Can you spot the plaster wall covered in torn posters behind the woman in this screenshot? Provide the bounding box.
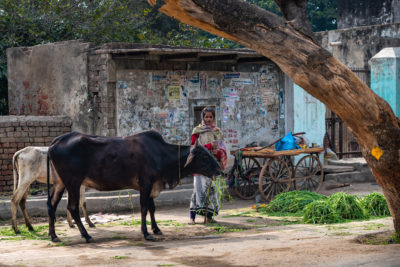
[116,64,284,155]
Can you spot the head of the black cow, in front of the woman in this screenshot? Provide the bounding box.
[185,145,222,177]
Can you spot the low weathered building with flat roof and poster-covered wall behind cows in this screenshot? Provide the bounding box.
[7,41,287,155]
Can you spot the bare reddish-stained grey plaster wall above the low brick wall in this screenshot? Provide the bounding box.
[7,41,90,132]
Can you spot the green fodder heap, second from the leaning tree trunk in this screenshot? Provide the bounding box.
[328,192,369,219]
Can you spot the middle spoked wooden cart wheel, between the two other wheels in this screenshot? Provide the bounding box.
[258,158,292,201]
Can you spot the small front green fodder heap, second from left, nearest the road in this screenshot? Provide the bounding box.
[303,200,342,223]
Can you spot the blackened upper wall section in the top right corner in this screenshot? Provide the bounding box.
[338,0,400,29]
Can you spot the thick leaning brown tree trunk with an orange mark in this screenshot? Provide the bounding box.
[148,0,400,234]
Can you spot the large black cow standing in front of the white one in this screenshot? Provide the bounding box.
[47,131,221,242]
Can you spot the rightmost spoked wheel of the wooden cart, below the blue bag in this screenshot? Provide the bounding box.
[294,155,324,191]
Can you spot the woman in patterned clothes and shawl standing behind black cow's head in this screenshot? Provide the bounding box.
[190,107,227,224]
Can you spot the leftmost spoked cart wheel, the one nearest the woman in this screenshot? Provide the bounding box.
[235,157,261,199]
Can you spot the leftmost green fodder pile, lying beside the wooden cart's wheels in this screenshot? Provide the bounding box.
[265,190,327,216]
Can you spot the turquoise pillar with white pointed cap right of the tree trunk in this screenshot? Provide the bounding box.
[370,47,400,117]
